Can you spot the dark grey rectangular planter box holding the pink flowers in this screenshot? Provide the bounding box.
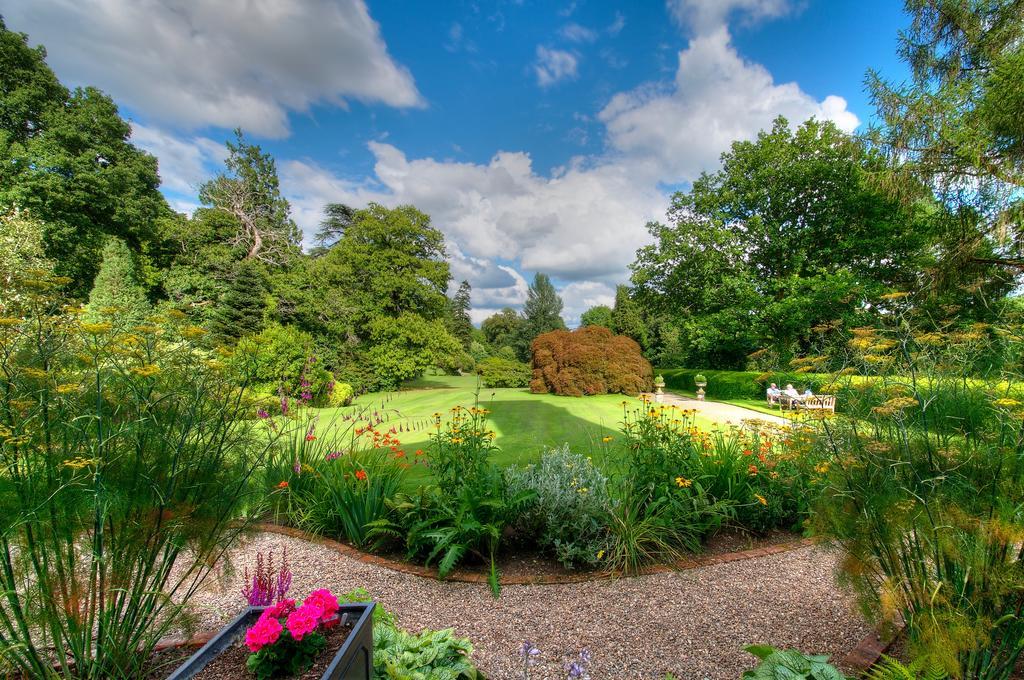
[167,602,374,680]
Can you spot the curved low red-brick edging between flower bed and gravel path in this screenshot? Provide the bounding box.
[253,523,814,586]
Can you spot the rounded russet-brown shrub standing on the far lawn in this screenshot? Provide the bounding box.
[529,326,653,396]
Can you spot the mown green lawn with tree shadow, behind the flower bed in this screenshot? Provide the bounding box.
[321,376,714,477]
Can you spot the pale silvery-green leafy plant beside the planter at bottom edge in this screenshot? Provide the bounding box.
[374,623,483,680]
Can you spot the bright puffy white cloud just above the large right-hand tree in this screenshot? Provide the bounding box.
[598,28,859,183]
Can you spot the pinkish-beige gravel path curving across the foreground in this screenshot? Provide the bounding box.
[184,534,868,680]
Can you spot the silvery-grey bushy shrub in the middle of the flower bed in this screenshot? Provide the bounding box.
[505,444,610,568]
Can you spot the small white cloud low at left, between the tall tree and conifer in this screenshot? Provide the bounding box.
[131,123,227,193]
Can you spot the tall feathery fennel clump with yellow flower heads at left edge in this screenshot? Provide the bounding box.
[0,273,272,678]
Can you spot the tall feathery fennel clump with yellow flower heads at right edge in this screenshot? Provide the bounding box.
[813,309,1024,680]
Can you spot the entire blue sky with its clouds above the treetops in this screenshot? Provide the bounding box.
[0,0,906,324]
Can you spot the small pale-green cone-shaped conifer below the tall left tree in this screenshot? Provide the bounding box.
[86,237,151,326]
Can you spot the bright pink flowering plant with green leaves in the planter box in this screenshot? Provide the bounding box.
[246,590,339,680]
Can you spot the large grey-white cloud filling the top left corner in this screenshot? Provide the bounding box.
[0,0,423,137]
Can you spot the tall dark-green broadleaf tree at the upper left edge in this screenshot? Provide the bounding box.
[0,19,170,299]
